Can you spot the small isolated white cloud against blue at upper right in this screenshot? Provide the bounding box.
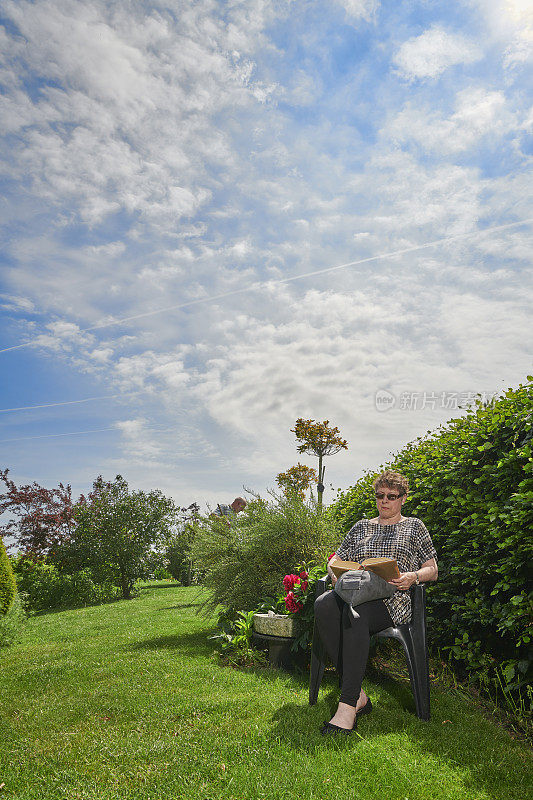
[393,25,482,79]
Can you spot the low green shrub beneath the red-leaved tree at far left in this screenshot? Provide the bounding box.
[13,556,117,611]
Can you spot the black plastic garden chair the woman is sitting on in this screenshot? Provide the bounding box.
[309,575,430,720]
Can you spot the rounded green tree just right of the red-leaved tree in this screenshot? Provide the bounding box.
[65,475,176,598]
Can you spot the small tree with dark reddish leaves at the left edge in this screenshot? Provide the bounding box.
[0,469,74,559]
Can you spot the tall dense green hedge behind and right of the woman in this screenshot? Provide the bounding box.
[329,376,533,708]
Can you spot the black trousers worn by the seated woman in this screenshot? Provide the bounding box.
[315,591,394,706]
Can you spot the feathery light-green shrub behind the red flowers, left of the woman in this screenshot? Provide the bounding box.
[193,493,339,611]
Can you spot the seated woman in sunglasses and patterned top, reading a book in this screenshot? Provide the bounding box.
[315,471,438,735]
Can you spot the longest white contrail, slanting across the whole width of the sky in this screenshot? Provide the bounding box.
[0,218,533,353]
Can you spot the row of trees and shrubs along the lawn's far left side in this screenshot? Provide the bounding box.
[0,469,199,610]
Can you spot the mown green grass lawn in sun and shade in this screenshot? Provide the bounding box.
[0,584,533,800]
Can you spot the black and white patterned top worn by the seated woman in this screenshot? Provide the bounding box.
[336,517,437,625]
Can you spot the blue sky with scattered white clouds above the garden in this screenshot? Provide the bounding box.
[0,0,533,507]
